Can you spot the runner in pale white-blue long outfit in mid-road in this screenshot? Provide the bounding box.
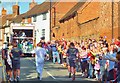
[34,43,47,80]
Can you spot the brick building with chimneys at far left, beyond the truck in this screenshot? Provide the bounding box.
[0,4,19,46]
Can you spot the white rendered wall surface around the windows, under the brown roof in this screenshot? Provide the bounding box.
[32,12,50,44]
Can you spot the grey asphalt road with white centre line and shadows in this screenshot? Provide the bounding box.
[20,57,97,83]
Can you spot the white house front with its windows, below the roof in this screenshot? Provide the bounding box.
[32,11,50,43]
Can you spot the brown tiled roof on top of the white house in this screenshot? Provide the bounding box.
[24,2,55,18]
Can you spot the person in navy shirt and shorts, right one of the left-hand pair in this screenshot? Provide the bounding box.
[10,40,23,81]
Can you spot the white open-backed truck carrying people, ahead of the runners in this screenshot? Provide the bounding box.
[10,23,36,56]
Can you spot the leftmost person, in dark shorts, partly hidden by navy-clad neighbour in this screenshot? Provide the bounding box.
[2,45,12,81]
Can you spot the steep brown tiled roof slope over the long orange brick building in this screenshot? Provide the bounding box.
[59,2,85,22]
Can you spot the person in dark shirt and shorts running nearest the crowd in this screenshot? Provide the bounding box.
[67,42,79,80]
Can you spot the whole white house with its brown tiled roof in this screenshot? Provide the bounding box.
[24,2,54,44]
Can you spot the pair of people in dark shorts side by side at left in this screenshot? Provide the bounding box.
[2,40,24,82]
